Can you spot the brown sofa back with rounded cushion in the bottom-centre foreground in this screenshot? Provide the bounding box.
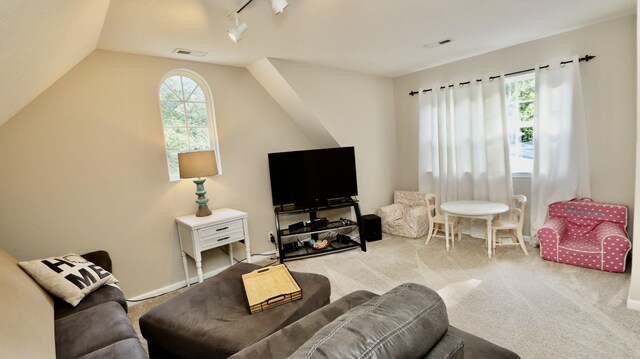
[230,283,520,359]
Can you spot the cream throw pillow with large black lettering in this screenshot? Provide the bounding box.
[18,253,118,307]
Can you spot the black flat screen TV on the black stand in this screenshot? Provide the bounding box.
[269,147,358,206]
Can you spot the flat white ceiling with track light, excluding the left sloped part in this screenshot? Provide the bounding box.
[98,0,636,77]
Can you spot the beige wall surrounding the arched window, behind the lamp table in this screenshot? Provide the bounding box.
[0,51,311,297]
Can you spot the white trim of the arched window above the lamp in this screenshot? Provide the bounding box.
[157,68,222,182]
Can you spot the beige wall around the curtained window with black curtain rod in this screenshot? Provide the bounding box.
[395,15,636,233]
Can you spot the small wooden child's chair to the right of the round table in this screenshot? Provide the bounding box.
[491,195,529,255]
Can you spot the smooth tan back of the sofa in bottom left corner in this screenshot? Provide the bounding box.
[0,249,55,358]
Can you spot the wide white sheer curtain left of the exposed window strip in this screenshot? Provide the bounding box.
[418,76,513,203]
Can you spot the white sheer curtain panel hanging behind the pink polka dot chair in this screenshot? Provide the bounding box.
[530,56,591,235]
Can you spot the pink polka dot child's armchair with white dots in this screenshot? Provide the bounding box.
[538,198,631,272]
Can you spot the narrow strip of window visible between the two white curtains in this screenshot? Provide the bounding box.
[505,73,536,175]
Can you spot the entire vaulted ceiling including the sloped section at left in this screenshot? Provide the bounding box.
[0,0,636,125]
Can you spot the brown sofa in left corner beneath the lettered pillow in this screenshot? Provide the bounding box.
[0,249,148,359]
